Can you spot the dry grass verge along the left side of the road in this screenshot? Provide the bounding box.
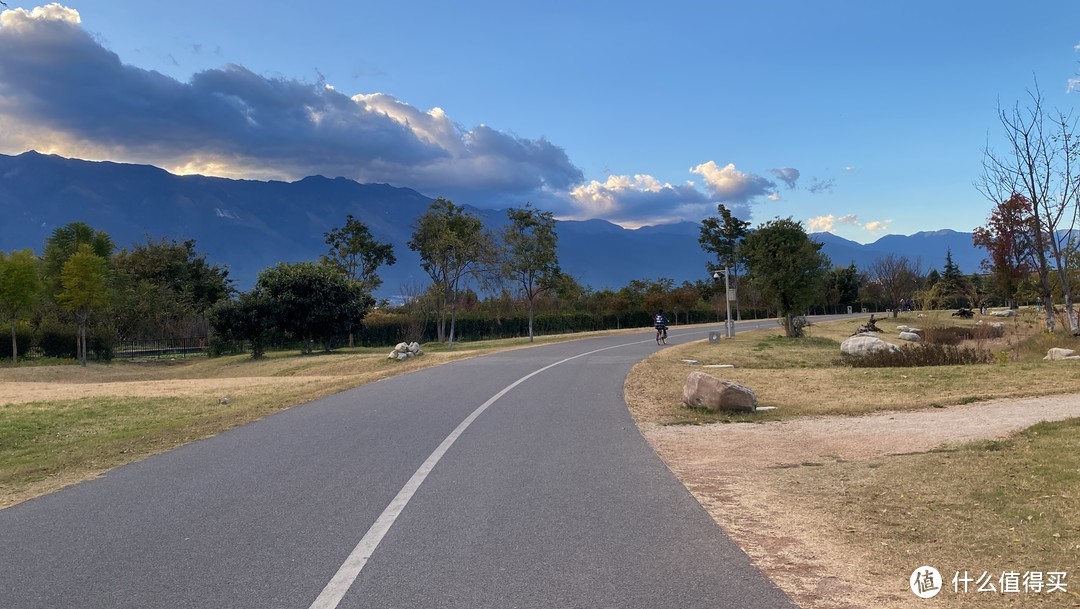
[0,328,642,508]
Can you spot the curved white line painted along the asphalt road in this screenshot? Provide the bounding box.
[309,338,669,609]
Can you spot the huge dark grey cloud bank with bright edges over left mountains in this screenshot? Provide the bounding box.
[0,3,584,204]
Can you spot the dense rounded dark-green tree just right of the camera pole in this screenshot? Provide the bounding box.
[742,218,828,337]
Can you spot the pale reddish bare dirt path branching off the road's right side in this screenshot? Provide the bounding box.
[640,395,1080,609]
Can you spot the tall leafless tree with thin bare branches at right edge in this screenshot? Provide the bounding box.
[976,83,1080,331]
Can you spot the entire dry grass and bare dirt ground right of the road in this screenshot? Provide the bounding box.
[626,315,1080,609]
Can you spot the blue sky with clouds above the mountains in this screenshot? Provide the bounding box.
[0,0,1080,243]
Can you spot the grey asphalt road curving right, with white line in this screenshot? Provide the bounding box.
[0,321,807,609]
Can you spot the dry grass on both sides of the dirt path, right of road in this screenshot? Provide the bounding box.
[626,313,1080,609]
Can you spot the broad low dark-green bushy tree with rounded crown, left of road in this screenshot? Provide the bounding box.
[256,262,374,354]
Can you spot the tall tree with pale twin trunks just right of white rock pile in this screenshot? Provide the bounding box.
[408,198,497,347]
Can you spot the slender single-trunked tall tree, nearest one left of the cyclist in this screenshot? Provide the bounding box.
[502,203,562,342]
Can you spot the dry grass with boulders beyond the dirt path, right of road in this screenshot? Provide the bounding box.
[626,313,1080,424]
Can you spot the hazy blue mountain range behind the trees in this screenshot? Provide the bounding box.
[0,151,986,297]
